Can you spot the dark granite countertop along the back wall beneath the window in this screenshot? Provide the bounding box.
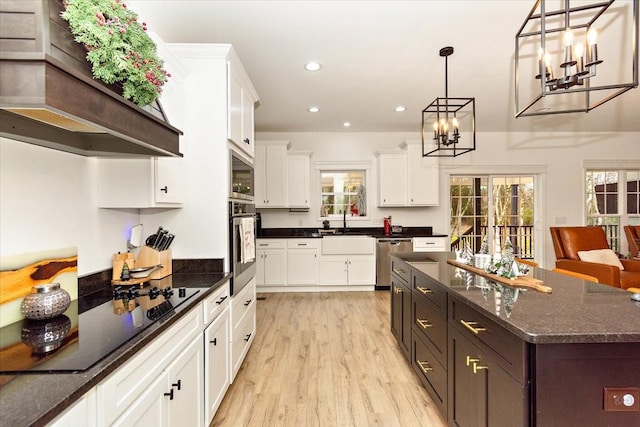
[257,227,447,239]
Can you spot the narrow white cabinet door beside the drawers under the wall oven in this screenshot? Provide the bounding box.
[204,307,231,425]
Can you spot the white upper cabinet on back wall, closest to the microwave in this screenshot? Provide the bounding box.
[254,141,289,208]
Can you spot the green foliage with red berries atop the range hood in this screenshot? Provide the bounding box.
[61,0,171,106]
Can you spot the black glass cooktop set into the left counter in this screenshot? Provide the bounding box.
[0,287,200,373]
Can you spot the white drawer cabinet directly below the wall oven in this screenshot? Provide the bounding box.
[231,278,256,383]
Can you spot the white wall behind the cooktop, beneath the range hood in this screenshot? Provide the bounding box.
[0,138,139,275]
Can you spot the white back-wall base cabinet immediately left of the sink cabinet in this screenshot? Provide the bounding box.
[287,239,320,286]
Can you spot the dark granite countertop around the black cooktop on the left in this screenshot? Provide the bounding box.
[0,273,232,427]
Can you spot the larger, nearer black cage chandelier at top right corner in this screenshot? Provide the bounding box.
[515,0,638,117]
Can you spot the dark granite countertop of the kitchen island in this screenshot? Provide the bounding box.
[391,252,640,344]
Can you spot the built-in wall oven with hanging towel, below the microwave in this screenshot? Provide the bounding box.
[229,200,256,295]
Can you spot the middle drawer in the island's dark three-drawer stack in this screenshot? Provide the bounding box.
[413,294,447,365]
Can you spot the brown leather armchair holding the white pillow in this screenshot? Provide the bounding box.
[550,227,640,289]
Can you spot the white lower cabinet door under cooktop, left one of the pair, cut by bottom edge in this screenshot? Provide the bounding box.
[112,374,170,427]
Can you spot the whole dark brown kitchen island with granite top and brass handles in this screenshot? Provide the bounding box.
[390,252,640,426]
